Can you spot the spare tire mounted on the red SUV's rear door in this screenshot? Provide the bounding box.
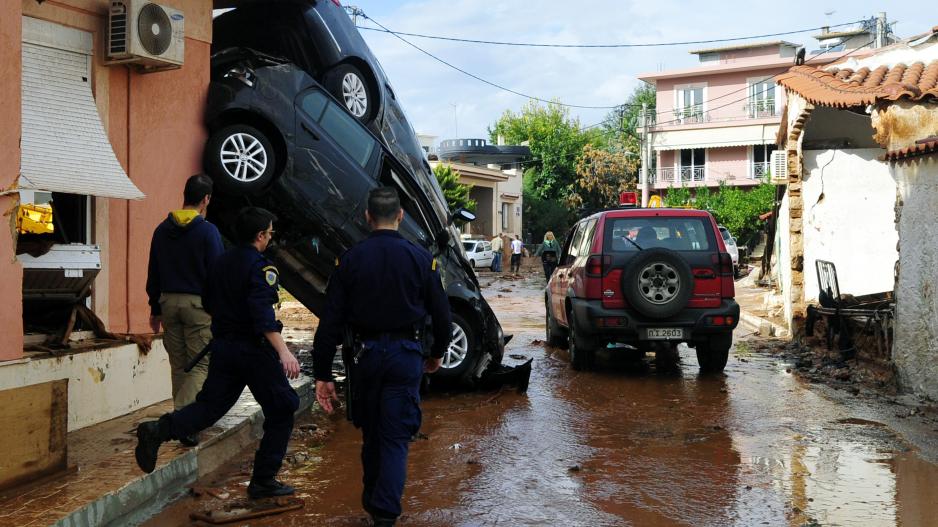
[622,247,694,318]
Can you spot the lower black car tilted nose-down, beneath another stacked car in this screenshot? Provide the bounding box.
[204,48,506,383]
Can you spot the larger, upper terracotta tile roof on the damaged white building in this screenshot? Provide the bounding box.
[778,60,938,108]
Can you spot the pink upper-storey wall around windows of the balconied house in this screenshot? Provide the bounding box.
[656,69,784,124]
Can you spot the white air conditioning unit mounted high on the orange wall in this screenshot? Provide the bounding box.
[107,0,186,69]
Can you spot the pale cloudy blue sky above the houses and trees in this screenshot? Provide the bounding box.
[343,0,938,145]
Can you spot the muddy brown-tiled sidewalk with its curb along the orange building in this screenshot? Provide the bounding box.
[0,376,315,527]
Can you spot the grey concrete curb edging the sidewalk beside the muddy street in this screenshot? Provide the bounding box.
[54,376,316,527]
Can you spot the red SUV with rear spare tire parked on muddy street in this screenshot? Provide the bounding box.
[544,209,739,372]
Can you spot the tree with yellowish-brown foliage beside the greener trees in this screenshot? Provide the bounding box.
[567,145,638,212]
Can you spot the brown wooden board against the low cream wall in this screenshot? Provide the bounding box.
[0,379,68,489]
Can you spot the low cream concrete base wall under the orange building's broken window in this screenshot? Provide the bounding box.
[0,341,171,431]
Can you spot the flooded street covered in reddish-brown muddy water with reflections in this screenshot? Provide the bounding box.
[147,276,938,526]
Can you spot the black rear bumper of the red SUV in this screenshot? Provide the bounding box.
[572,299,739,343]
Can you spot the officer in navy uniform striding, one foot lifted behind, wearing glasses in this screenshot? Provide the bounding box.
[135,207,300,498]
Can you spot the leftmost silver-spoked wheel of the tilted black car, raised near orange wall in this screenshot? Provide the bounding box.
[205,124,277,195]
